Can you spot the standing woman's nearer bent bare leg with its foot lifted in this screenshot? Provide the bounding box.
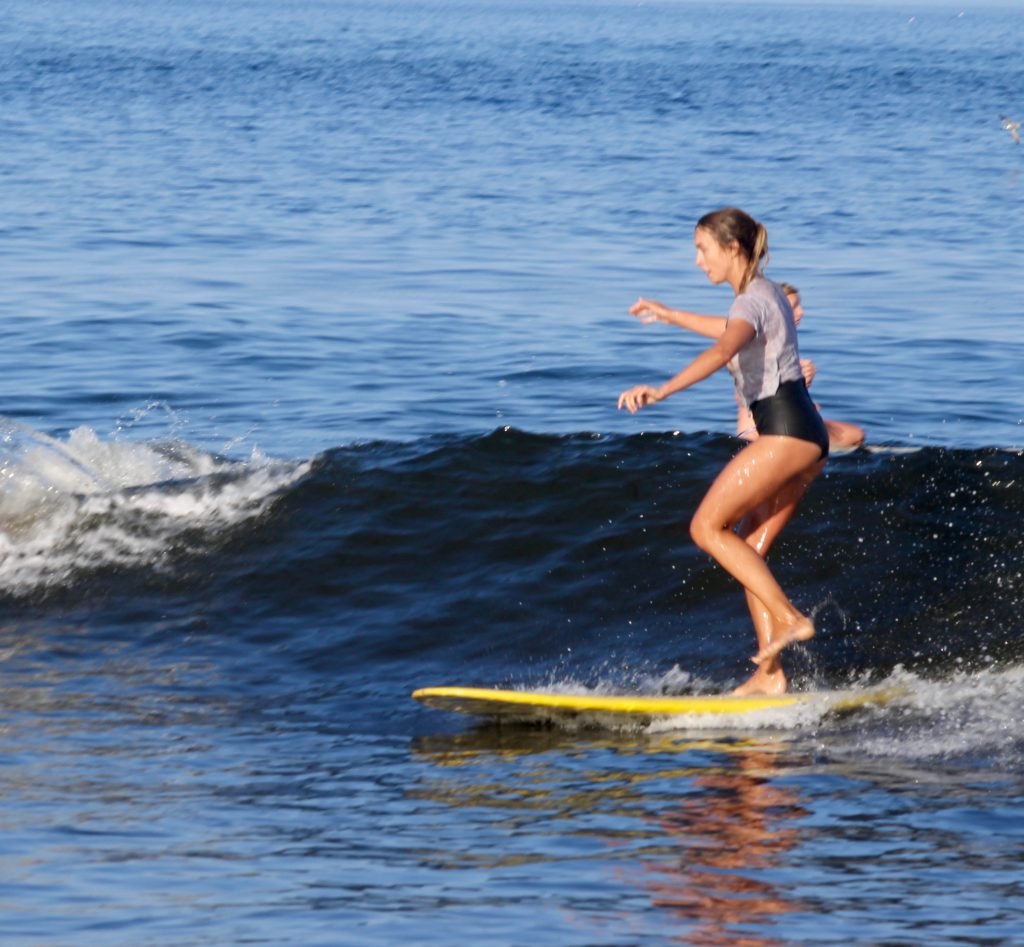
[690,436,820,664]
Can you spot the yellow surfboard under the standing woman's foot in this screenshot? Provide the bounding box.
[413,687,899,723]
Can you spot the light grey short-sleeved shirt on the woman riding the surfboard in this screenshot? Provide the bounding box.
[728,276,803,407]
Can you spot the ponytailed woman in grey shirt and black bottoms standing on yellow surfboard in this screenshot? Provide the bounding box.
[618,208,828,694]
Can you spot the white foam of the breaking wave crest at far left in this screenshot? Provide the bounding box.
[0,419,310,594]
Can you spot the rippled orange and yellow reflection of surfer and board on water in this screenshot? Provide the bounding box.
[413,728,809,947]
